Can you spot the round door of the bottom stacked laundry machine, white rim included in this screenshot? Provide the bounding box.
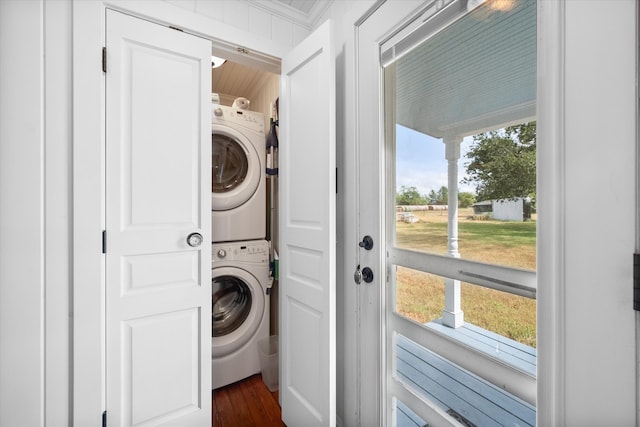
[211,267,265,358]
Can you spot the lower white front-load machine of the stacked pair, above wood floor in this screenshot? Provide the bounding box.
[211,240,271,389]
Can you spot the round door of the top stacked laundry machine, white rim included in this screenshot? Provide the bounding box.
[211,124,263,211]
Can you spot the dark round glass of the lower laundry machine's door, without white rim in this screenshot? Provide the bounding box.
[211,276,251,337]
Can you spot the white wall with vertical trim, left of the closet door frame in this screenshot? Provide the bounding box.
[0,0,71,426]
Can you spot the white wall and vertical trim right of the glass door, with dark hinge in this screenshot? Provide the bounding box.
[537,0,640,426]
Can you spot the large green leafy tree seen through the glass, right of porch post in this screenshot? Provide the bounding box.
[462,122,536,200]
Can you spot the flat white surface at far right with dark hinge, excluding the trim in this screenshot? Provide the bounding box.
[562,0,640,425]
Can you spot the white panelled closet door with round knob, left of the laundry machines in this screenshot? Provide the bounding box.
[105,11,211,426]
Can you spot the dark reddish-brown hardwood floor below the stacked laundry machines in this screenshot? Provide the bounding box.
[211,374,284,427]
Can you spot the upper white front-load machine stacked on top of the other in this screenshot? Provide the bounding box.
[211,105,267,243]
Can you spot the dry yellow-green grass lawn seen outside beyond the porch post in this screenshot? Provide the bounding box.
[396,209,536,347]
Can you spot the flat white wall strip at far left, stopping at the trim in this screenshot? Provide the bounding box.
[0,1,46,426]
